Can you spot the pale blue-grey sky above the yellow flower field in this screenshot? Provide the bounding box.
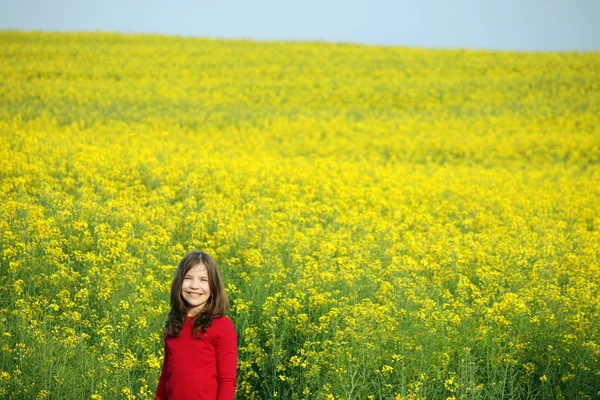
[0,0,600,51]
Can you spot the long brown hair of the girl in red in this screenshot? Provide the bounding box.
[165,250,229,337]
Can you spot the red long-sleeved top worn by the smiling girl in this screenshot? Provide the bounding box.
[156,317,237,400]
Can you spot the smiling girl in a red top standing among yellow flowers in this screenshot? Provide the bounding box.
[156,250,237,400]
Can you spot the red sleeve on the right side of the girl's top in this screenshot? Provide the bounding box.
[215,317,237,400]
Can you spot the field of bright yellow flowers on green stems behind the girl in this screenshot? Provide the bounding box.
[0,31,600,399]
